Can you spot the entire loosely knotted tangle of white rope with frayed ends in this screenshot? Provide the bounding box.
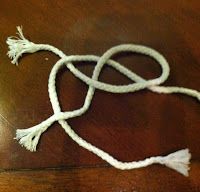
[7,27,200,176]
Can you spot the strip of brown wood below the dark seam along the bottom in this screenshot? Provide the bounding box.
[0,163,200,192]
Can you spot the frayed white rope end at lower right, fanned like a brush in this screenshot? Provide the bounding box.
[162,149,191,177]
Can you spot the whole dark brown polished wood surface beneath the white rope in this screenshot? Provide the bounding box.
[0,0,200,192]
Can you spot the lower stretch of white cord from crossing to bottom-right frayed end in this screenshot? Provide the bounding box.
[59,120,191,176]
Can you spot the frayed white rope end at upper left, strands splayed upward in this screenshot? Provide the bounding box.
[6,26,37,65]
